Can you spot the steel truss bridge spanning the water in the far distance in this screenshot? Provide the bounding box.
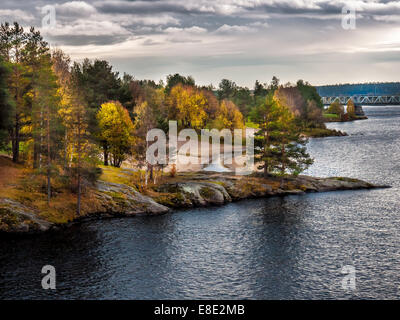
[321,95,400,105]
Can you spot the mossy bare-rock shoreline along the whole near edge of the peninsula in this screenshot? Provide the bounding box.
[0,173,388,234]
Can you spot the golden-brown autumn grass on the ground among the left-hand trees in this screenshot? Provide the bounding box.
[0,155,192,225]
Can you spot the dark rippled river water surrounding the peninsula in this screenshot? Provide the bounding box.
[0,107,400,299]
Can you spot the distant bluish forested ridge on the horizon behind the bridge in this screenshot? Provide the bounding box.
[316,82,400,97]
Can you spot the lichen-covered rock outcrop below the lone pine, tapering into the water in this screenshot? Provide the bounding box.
[153,173,386,208]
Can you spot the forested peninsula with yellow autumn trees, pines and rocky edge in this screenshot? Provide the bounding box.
[0,23,388,233]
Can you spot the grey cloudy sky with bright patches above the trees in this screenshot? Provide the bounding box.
[0,0,400,87]
